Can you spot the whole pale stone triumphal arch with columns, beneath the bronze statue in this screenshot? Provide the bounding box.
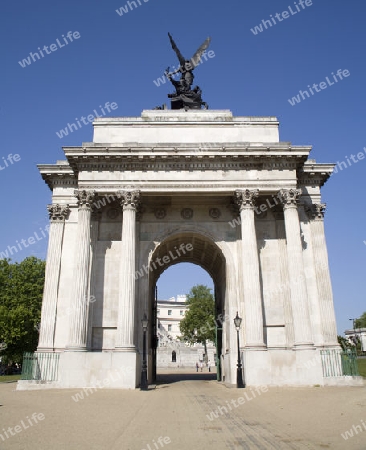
[25,109,339,388]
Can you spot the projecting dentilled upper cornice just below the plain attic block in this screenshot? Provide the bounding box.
[64,143,311,172]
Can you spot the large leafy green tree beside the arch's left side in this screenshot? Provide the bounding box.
[0,256,46,363]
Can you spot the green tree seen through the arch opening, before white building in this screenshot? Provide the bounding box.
[180,284,216,359]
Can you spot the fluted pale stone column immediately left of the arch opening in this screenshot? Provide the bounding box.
[115,191,140,351]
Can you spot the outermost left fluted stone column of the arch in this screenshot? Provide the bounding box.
[37,204,70,352]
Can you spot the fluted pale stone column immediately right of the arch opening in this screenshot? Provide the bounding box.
[235,189,265,350]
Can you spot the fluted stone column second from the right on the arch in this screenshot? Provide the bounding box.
[279,189,314,350]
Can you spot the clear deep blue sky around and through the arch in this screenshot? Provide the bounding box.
[0,0,366,332]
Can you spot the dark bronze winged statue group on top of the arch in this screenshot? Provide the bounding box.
[165,33,211,110]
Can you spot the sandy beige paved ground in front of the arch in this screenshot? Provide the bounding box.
[0,369,366,450]
